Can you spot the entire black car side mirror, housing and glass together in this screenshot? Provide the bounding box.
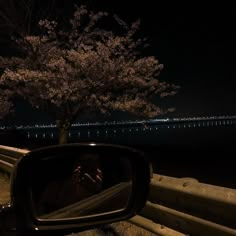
[11,144,150,234]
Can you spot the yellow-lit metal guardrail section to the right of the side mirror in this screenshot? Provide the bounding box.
[130,174,236,236]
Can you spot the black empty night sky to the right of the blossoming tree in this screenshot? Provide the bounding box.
[0,0,236,123]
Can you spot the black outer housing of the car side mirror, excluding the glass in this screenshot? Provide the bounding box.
[11,143,150,234]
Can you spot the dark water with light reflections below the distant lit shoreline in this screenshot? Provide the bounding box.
[0,124,236,188]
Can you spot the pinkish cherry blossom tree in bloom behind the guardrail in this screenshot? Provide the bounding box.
[0,6,178,143]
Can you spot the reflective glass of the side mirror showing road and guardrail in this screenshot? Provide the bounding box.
[30,152,133,220]
